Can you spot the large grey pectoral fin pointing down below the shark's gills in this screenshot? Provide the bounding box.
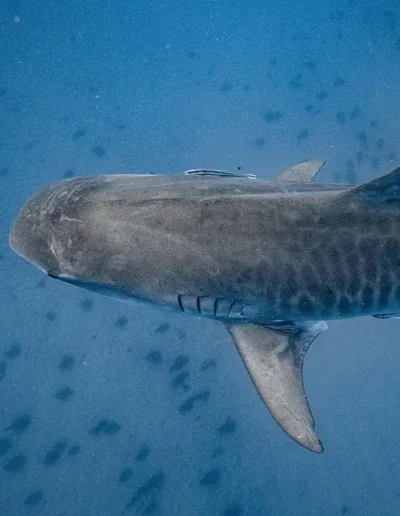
[227,321,327,453]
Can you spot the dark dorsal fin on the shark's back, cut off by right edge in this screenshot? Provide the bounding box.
[340,167,400,204]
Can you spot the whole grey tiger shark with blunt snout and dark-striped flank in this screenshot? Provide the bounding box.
[10,160,400,453]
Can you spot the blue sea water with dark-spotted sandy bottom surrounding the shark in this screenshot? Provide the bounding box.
[0,0,400,516]
